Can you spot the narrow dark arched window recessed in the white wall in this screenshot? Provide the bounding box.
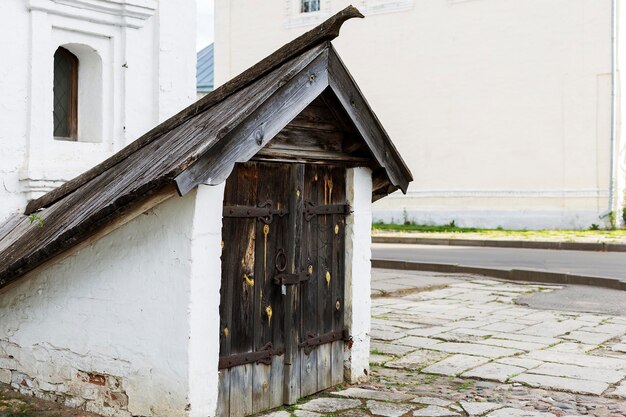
[53,47,78,140]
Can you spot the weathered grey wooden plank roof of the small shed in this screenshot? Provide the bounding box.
[0,6,412,288]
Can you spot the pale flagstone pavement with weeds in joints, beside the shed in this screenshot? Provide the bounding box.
[264,270,626,417]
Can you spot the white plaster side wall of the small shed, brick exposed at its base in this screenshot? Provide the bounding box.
[0,191,197,417]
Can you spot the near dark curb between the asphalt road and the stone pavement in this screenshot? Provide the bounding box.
[372,259,626,291]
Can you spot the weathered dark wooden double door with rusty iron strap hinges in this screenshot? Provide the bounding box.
[218,162,349,417]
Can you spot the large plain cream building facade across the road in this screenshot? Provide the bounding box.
[215,0,626,229]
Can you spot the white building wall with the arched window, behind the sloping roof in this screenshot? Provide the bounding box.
[0,0,196,222]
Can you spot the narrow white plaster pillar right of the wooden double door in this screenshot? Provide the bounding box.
[344,168,372,383]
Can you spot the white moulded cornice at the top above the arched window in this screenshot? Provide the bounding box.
[25,0,158,29]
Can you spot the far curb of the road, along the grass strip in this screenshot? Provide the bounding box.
[372,236,626,252]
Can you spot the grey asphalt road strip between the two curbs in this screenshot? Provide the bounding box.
[372,243,626,281]
